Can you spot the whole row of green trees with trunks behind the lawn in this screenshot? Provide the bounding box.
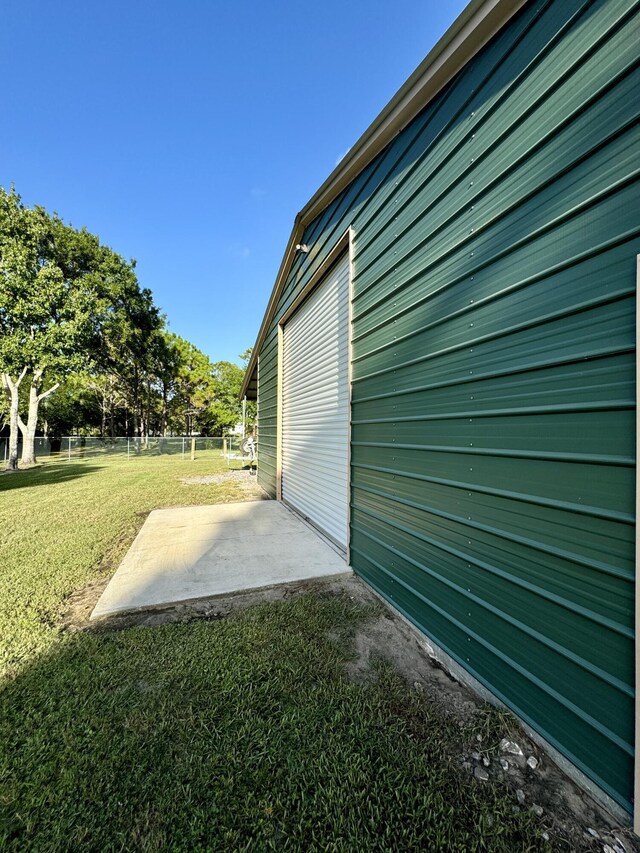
[0,187,251,467]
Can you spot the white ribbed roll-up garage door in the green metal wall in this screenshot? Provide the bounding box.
[282,256,349,548]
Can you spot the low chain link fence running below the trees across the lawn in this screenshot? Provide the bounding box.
[0,435,255,468]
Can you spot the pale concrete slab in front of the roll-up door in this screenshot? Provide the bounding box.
[91,501,351,619]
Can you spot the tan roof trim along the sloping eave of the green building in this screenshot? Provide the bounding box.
[241,0,527,396]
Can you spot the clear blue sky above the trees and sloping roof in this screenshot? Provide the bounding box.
[0,0,466,361]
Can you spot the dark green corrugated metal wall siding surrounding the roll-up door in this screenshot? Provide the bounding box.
[259,0,640,807]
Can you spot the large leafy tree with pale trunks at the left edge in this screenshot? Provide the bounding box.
[0,187,156,468]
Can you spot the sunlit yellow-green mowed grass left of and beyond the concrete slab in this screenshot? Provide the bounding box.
[0,452,250,675]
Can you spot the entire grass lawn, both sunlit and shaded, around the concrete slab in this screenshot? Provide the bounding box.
[0,457,545,853]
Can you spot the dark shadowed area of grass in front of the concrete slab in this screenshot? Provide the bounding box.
[0,596,545,851]
